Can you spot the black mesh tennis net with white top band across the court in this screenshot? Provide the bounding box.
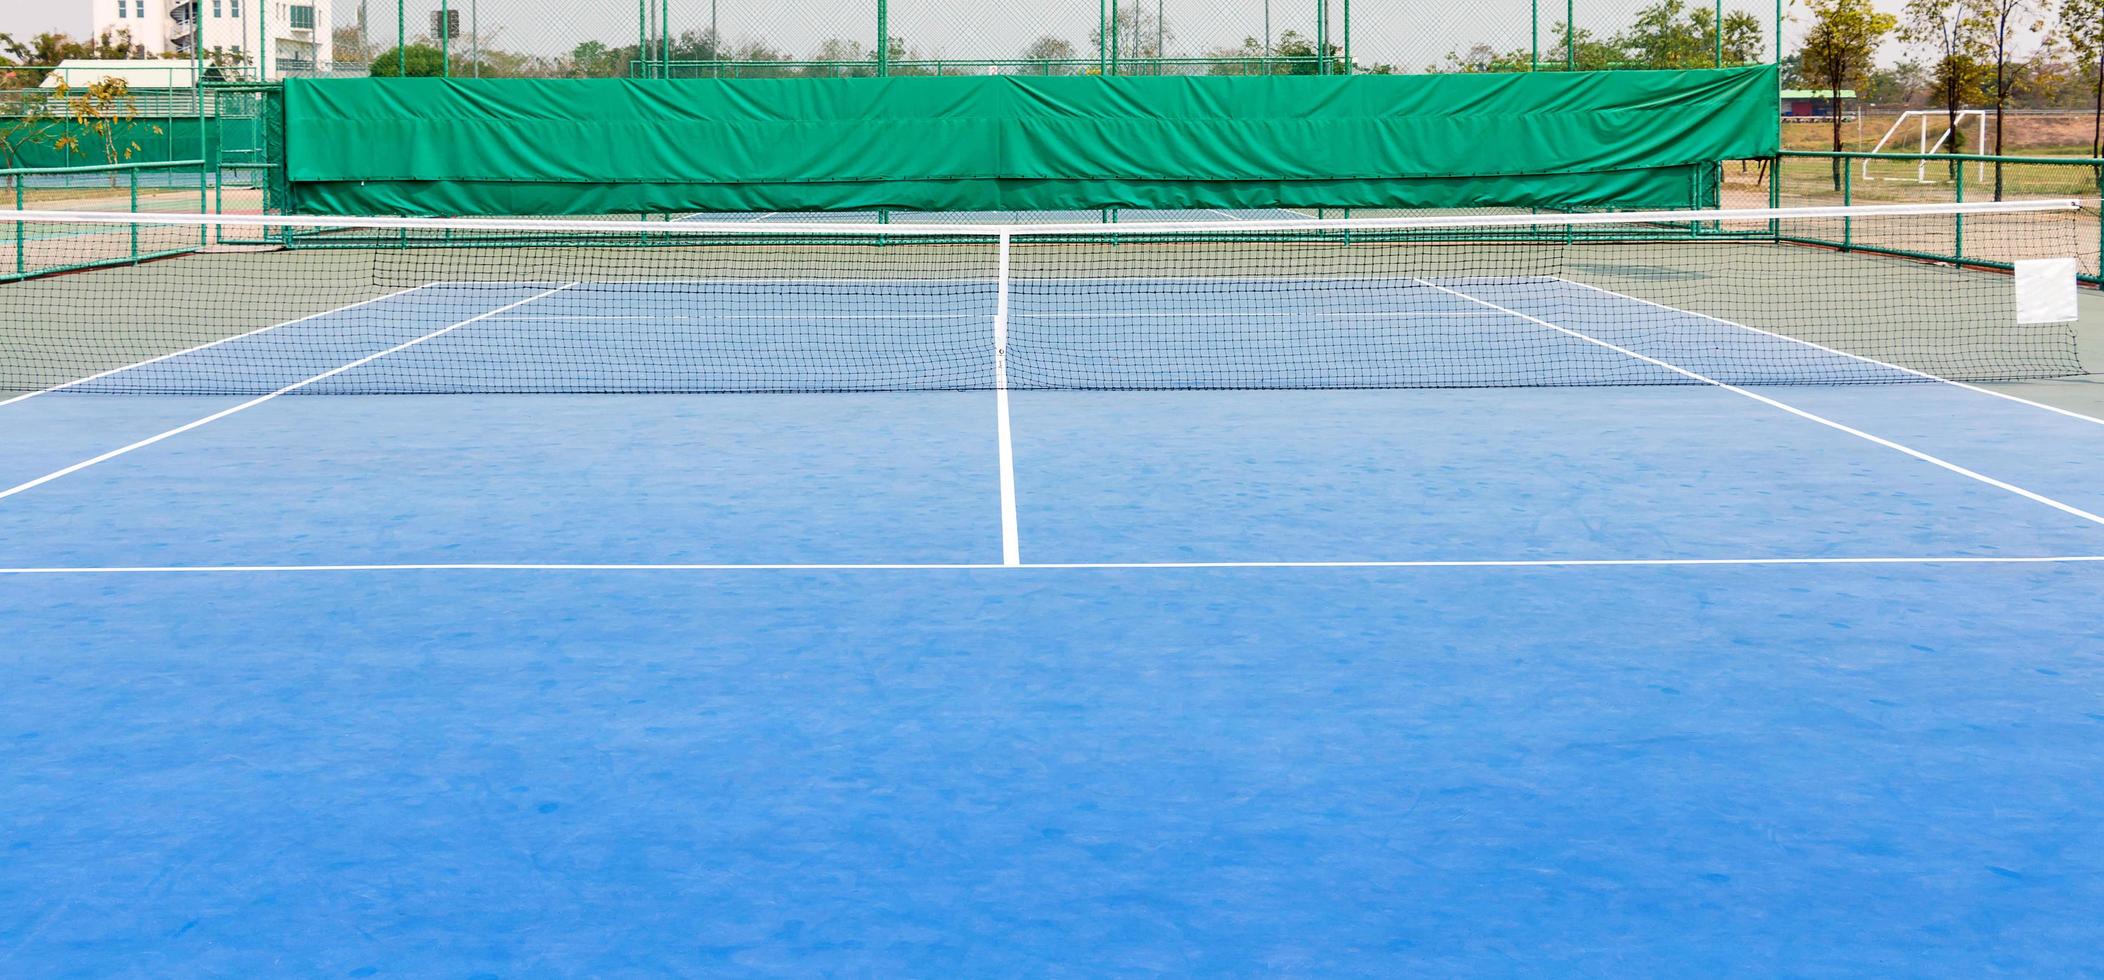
[0,202,2096,395]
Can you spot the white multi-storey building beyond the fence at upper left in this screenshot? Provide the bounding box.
[88,0,332,80]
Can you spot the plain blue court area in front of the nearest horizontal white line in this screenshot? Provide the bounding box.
[0,566,2104,976]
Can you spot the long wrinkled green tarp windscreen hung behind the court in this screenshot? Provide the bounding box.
[286,65,1778,215]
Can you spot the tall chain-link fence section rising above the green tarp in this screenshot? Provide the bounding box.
[318,0,1784,78]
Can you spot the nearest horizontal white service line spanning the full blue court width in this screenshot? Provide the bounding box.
[0,555,2104,576]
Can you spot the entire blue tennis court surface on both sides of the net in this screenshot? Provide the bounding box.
[0,275,2104,976]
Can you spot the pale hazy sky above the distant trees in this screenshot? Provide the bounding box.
[0,0,2036,72]
